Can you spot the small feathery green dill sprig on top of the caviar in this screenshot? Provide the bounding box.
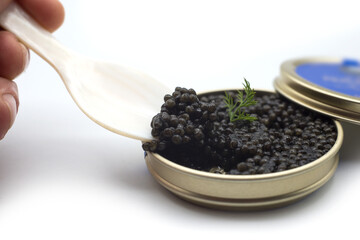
[224,78,257,122]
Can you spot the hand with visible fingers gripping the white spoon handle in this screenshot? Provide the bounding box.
[0,0,65,140]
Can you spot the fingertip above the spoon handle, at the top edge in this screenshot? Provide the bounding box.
[17,0,65,32]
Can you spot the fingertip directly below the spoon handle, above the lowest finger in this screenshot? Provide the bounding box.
[0,31,30,79]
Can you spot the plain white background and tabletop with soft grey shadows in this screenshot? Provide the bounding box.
[0,0,360,240]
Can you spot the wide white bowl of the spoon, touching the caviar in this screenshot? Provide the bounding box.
[59,57,169,141]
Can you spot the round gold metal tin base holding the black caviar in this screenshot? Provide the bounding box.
[145,91,343,210]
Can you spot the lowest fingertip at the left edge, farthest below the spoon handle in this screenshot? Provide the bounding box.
[0,77,19,139]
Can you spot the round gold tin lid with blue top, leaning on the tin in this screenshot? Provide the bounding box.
[274,58,360,124]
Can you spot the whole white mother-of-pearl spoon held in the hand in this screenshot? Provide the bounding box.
[0,3,170,141]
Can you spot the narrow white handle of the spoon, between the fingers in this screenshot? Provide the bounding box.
[0,2,70,69]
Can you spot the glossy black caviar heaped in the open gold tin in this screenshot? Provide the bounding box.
[143,87,337,175]
